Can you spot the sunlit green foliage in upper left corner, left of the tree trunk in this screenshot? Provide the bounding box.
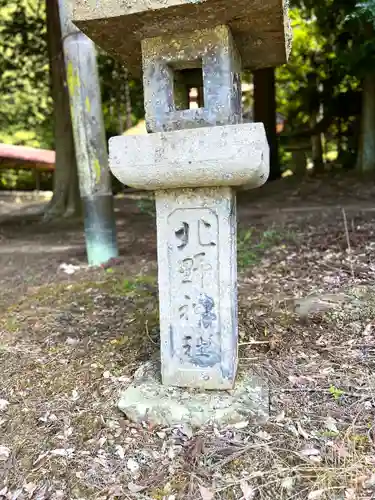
[0,0,52,147]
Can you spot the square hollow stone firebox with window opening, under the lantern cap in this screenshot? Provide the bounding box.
[142,26,242,132]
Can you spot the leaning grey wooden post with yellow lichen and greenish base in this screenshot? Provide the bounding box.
[58,0,118,265]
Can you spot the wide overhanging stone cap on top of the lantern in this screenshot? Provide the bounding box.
[73,0,291,76]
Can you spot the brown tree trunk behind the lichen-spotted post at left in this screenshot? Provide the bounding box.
[44,0,81,220]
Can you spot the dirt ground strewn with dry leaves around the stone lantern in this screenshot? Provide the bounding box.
[0,174,375,500]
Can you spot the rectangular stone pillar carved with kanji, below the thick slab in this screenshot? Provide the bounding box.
[155,188,237,389]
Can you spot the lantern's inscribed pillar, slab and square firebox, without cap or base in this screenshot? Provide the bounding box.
[110,25,268,389]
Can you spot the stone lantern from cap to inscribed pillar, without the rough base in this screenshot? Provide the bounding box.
[74,0,290,426]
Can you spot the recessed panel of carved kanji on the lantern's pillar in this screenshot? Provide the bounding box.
[168,208,220,368]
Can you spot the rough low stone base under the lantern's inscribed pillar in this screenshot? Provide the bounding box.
[118,361,269,428]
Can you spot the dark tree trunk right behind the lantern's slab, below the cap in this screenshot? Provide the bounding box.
[253,68,281,180]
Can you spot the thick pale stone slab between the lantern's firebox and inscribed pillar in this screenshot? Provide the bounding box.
[109,123,269,190]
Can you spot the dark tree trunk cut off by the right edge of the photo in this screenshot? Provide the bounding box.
[357,74,375,172]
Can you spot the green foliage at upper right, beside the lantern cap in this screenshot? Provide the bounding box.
[277,0,375,167]
